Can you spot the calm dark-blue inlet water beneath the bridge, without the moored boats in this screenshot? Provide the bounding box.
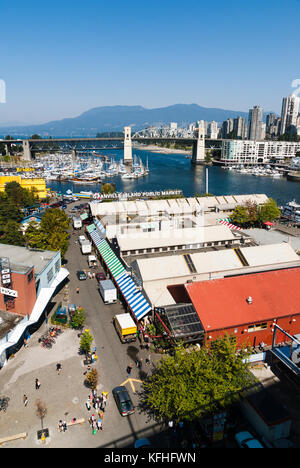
[47,150,300,205]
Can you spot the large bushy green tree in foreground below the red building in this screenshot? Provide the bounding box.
[142,336,253,422]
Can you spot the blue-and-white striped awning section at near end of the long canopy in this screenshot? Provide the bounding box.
[115,273,151,320]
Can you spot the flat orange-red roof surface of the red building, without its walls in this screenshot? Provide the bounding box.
[185,268,300,331]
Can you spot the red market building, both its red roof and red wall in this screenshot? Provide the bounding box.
[185,268,300,347]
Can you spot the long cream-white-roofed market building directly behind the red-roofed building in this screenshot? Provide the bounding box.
[130,242,300,307]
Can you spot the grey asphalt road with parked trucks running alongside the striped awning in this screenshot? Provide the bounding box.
[66,218,164,447]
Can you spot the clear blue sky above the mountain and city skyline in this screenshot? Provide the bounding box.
[0,0,300,124]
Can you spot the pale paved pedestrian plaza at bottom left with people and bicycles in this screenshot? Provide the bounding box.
[0,325,103,448]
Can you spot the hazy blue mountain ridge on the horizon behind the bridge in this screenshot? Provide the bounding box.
[0,104,253,137]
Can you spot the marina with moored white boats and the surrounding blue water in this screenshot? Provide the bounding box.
[2,148,300,206]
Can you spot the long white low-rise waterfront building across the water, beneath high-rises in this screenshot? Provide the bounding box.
[221,140,300,164]
